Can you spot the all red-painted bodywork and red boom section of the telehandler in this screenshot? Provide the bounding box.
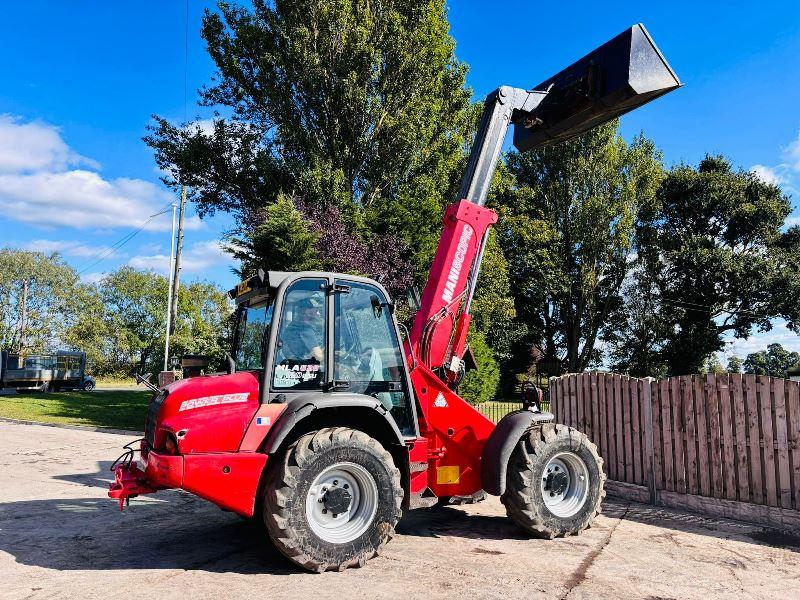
[109,200,504,516]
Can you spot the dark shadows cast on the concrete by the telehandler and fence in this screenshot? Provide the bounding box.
[0,462,800,575]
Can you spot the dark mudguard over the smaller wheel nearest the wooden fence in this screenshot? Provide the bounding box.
[481,410,554,496]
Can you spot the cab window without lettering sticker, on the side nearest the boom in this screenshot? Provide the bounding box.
[333,280,415,435]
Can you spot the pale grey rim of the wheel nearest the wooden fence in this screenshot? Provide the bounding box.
[541,452,589,518]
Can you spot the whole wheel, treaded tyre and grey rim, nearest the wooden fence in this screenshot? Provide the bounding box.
[500,423,606,539]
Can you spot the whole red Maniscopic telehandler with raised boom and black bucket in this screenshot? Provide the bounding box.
[109,25,681,572]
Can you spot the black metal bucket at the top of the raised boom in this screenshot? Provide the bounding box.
[514,23,681,152]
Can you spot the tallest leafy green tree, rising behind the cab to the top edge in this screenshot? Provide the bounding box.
[146,0,475,266]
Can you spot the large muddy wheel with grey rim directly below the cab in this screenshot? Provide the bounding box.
[263,427,403,572]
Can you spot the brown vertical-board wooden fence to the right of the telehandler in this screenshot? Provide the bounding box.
[550,373,800,528]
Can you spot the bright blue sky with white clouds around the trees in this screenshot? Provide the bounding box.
[0,0,800,354]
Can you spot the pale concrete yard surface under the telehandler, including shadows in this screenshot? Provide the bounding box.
[0,422,800,600]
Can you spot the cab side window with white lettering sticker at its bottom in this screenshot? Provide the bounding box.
[272,279,327,390]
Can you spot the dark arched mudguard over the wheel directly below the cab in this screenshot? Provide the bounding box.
[264,392,403,454]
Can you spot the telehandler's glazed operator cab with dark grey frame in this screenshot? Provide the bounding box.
[229,270,418,437]
